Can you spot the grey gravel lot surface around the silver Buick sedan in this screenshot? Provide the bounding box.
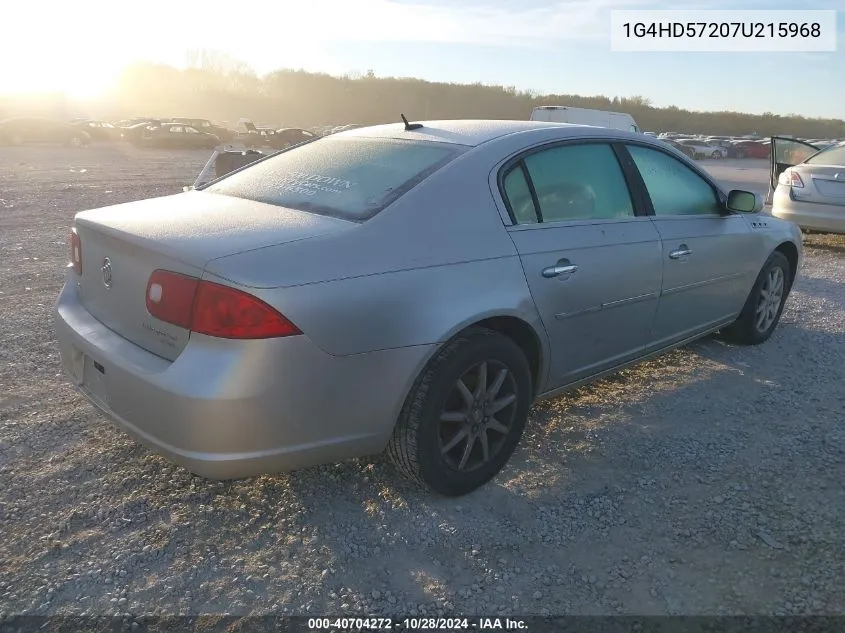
[0,147,845,615]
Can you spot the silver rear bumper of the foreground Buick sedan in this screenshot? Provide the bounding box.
[55,278,428,479]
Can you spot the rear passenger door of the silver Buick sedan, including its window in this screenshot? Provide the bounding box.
[501,142,661,389]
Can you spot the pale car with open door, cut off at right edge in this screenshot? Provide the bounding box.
[770,136,845,234]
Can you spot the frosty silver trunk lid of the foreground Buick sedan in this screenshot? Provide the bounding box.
[72,191,357,360]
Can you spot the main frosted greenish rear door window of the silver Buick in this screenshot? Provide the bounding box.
[525,143,634,222]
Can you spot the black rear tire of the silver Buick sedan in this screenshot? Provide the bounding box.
[387,328,533,496]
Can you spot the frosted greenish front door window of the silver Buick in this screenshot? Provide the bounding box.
[628,145,721,215]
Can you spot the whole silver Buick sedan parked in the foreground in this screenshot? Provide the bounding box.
[55,121,801,495]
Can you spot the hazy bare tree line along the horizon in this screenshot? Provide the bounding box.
[0,57,845,138]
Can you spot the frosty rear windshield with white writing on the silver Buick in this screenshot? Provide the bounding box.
[205,137,463,221]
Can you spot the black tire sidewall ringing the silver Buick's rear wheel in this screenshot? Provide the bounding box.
[416,333,533,496]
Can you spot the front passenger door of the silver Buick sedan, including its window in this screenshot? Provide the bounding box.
[626,144,762,351]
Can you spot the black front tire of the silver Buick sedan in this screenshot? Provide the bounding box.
[719,251,793,345]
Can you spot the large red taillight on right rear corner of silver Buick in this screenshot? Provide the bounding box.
[146,270,302,339]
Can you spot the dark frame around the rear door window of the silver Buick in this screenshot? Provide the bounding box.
[496,138,653,229]
